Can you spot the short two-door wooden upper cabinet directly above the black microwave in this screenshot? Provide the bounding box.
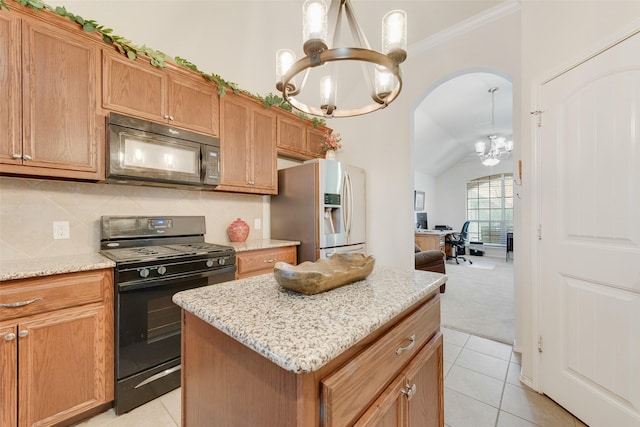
[102,50,220,136]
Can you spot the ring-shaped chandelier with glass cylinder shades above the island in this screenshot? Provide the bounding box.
[276,0,407,117]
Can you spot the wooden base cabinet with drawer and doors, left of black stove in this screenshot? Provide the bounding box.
[0,270,113,427]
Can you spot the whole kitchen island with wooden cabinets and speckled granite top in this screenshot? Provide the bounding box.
[173,267,446,427]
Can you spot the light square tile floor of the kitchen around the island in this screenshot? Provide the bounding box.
[72,328,585,427]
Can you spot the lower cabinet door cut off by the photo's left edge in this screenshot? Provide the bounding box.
[0,325,18,427]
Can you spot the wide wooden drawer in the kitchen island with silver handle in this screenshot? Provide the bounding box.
[321,295,440,427]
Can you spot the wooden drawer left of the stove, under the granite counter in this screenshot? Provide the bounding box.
[0,270,111,320]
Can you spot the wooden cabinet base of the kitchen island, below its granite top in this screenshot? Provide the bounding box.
[182,290,444,427]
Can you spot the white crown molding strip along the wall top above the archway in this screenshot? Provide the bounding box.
[407,0,520,55]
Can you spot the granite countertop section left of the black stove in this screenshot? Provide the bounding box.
[0,253,116,282]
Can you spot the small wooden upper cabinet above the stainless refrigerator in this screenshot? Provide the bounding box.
[277,111,328,160]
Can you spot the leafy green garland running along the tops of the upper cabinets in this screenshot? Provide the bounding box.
[0,0,326,127]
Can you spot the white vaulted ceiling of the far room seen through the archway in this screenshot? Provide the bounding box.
[414,73,513,176]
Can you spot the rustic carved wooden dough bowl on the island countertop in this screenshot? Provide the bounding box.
[273,253,375,295]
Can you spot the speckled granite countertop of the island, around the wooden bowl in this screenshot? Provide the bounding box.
[173,266,447,374]
